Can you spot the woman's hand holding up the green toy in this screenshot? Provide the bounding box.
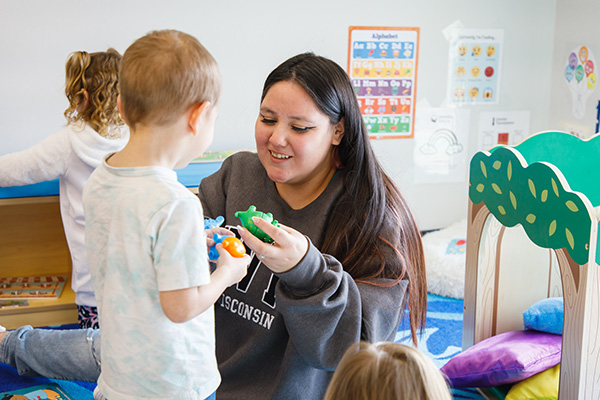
[238,217,308,273]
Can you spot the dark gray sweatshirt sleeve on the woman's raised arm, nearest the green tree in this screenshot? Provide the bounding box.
[276,239,406,370]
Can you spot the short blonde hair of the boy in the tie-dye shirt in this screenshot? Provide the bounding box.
[119,30,221,128]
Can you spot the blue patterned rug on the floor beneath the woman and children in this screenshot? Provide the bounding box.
[0,294,484,400]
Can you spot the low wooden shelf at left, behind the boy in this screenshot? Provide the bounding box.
[0,196,77,329]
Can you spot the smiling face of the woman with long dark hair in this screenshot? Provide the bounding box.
[255,81,343,190]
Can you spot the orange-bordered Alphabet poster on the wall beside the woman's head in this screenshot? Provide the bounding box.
[348,26,419,139]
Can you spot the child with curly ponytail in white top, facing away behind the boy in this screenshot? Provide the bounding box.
[0,48,129,328]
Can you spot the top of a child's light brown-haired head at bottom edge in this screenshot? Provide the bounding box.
[324,342,452,400]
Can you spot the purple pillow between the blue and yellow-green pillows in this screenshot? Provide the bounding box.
[442,330,562,387]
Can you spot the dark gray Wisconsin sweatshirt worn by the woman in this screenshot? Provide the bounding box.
[199,152,406,400]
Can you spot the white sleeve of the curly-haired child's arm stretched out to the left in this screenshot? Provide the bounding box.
[0,130,71,187]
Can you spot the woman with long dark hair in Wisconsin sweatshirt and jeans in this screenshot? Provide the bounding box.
[0,53,426,399]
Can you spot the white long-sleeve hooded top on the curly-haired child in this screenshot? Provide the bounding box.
[0,123,129,307]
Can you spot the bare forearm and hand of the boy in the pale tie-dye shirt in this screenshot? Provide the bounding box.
[160,244,250,323]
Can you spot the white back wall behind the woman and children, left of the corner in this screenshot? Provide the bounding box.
[0,0,556,229]
